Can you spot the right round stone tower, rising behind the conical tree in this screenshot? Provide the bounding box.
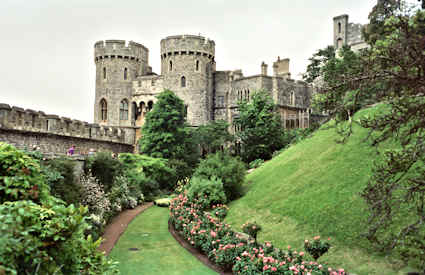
[161,35,215,126]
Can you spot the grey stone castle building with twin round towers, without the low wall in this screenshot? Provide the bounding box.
[94,35,313,142]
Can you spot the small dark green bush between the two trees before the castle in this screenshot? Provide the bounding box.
[196,120,234,155]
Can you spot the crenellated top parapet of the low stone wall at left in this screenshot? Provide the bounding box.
[0,103,134,145]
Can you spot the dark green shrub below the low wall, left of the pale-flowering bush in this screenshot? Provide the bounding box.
[43,158,82,205]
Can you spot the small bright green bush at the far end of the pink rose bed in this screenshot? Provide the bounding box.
[187,177,226,209]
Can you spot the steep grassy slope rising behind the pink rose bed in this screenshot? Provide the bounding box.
[226,110,408,274]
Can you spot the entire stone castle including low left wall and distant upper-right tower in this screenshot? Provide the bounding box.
[0,15,366,154]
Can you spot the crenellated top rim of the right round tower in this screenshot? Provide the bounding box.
[161,35,215,60]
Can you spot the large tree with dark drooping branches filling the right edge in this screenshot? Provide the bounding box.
[304,1,425,268]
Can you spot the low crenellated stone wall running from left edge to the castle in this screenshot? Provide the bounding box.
[0,104,136,154]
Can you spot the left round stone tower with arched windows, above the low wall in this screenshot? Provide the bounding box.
[94,40,150,126]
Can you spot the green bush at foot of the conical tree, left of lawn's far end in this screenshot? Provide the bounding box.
[119,153,177,191]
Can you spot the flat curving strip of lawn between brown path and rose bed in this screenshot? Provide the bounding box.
[109,207,217,275]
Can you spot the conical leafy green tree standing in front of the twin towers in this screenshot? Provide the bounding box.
[140,90,199,176]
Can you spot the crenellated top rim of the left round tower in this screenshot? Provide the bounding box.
[94,40,149,62]
